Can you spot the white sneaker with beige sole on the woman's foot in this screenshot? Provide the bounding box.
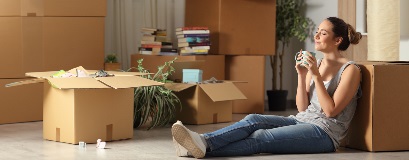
[172,121,206,158]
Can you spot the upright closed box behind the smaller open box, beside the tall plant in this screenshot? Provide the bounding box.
[226,55,266,114]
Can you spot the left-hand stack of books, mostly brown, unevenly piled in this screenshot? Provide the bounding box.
[139,28,178,55]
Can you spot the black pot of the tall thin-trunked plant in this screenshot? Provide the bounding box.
[267,90,288,111]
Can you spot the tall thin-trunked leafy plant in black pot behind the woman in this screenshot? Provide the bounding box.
[267,0,313,110]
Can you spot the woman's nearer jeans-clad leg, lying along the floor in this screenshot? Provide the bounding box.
[206,123,335,156]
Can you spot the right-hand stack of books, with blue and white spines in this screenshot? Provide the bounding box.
[176,27,211,55]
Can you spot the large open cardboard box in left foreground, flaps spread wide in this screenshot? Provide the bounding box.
[7,67,163,144]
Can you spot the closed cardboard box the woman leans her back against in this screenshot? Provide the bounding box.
[346,62,409,151]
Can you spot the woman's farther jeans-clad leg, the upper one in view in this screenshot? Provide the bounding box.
[203,114,297,151]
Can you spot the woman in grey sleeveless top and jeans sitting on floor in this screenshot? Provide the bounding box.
[172,17,362,158]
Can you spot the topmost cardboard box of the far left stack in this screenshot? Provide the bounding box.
[0,0,107,17]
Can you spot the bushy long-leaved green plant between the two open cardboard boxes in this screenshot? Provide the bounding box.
[128,58,182,130]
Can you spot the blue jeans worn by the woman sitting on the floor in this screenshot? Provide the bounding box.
[203,114,335,156]
